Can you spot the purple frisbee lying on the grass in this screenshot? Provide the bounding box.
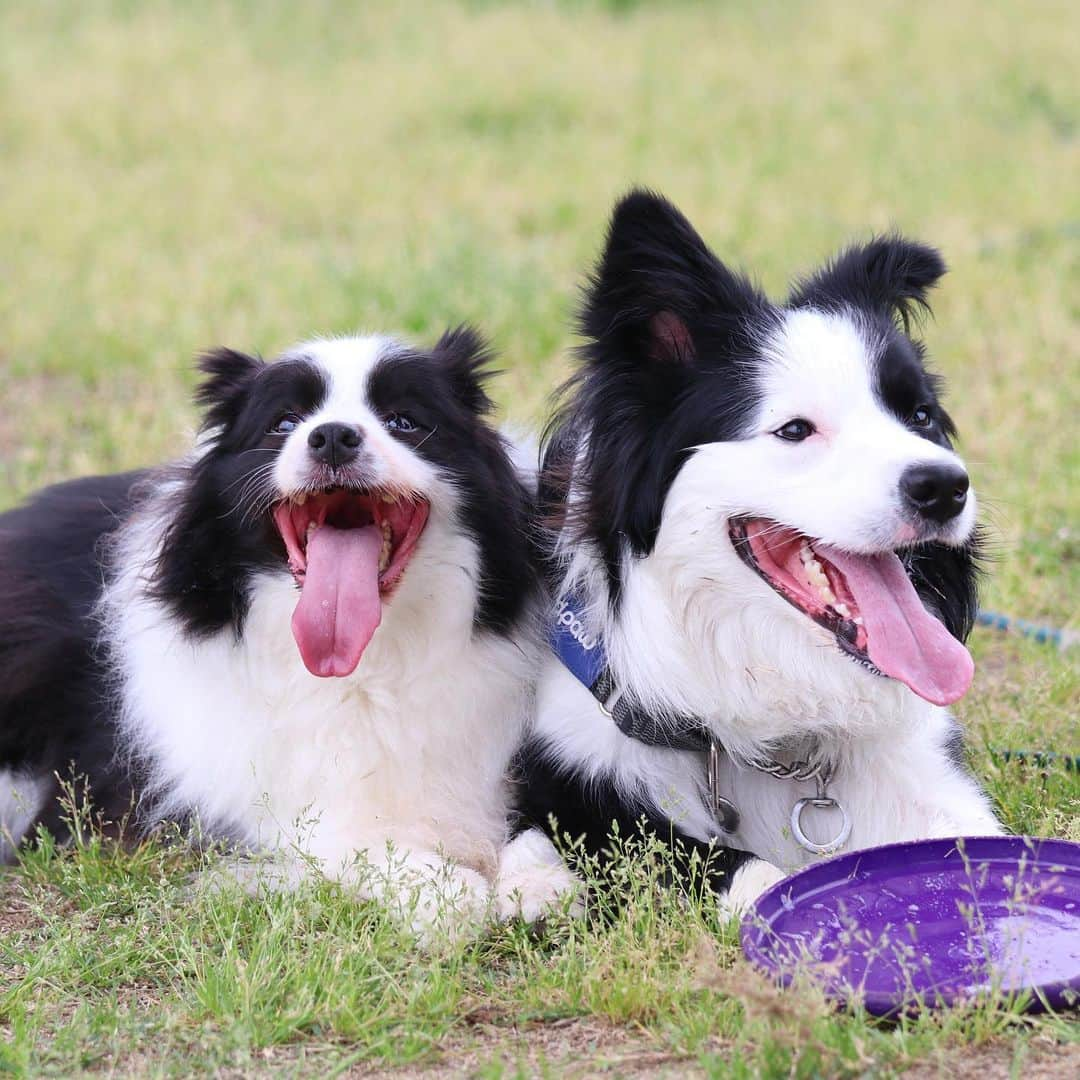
[742,836,1080,1016]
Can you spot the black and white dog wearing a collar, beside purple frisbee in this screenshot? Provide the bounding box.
[507,192,1000,907]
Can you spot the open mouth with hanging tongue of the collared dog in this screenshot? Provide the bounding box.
[728,517,974,705]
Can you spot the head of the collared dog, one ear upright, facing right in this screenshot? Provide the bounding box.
[549,192,975,703]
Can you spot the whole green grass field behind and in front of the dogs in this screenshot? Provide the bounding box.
[0,0,1080,1077]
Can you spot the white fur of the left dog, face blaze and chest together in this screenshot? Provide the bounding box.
[102,338,536,937]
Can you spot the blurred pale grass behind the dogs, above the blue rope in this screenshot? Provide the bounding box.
[0,0,1080,622]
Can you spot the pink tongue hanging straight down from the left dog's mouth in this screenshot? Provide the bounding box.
[293,525,382,676]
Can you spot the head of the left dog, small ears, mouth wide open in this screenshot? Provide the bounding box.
[158,328,529,675]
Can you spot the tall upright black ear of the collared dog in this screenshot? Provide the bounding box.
[580,190,765,366]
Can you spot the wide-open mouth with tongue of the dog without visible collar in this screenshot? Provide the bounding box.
[273,487,429,676]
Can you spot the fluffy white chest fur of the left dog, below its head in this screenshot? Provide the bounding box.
[106,509,530,877]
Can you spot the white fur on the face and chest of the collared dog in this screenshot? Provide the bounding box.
[518,310,1000,906]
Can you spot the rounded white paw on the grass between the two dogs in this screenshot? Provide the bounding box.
[496,828,584,922]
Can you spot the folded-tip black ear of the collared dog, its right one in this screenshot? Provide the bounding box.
[788,235,945,329]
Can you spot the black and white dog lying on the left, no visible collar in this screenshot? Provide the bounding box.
[0,329,536,919]
